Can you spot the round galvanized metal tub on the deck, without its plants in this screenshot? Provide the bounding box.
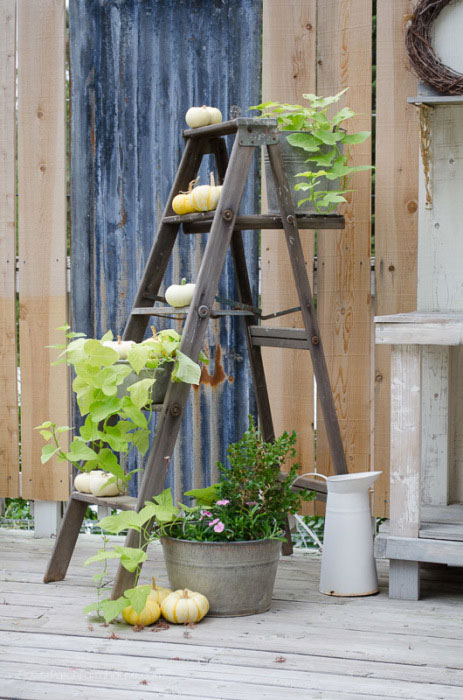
[161,537,281,617]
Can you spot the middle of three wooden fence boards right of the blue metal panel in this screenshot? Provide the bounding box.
[317,0,372,486]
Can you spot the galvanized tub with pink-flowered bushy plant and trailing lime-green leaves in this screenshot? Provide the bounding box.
[87,418,313,621]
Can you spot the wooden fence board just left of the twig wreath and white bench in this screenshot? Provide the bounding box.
[374,0,418,517]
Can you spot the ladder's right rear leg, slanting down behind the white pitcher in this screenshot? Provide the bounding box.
[267,143,348,474]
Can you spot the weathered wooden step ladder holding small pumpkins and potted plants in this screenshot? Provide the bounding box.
[44,118,347,597]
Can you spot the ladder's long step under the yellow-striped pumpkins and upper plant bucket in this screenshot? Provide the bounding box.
[163,212,344,233]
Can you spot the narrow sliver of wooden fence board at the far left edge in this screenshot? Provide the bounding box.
[0,0,19,498]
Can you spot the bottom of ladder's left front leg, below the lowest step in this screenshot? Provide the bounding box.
[43,498,88,583]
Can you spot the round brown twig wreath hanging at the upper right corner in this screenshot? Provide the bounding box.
[405,0,463,95]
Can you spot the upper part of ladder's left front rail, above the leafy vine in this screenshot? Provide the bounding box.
[123,139,206,342]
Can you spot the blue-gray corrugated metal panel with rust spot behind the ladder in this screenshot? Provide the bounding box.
[70,0,262,496]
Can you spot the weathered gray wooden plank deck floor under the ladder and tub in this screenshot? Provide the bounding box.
[0,530,463,700]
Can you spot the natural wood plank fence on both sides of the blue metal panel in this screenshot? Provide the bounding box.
[0,0,418,516]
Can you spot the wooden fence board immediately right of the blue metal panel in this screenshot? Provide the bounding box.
[261,0,316,516]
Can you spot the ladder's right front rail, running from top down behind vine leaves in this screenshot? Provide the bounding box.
[112,138,254,599]
